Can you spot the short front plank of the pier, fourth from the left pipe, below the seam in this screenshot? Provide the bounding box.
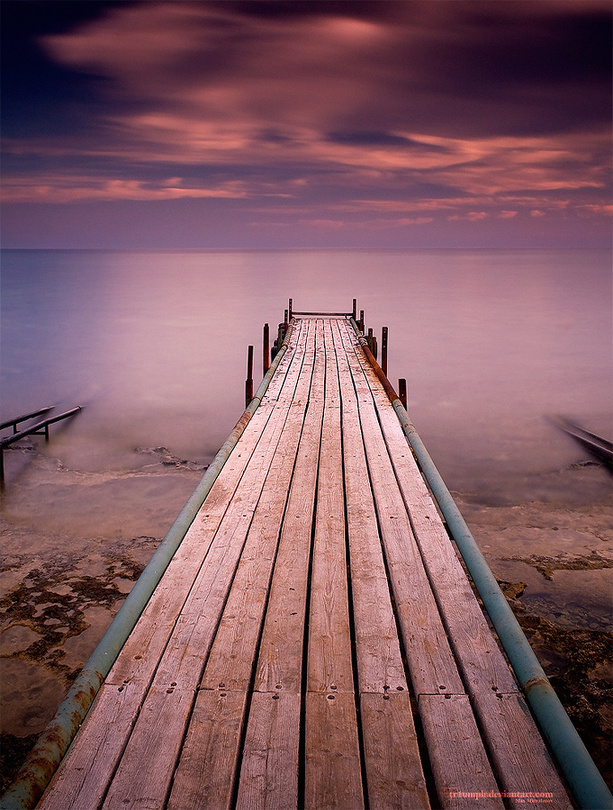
[236,691,301,810]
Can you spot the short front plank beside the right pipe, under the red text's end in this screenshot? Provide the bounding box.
[477,691,572,810]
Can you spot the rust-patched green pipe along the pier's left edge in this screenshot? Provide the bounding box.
[0,326,291,810]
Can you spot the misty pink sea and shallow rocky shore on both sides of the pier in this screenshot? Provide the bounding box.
[0,250,613,776]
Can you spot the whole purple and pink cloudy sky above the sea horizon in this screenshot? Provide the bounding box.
[0,0,613,249]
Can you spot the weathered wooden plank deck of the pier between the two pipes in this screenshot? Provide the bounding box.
[33,313,572,810]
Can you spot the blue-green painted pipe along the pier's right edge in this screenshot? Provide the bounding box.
[351,318,613,810]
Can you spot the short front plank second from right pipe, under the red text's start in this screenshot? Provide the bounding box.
[419,695,504,810]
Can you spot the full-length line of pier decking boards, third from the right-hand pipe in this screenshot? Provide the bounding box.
[334,320,429,810]
